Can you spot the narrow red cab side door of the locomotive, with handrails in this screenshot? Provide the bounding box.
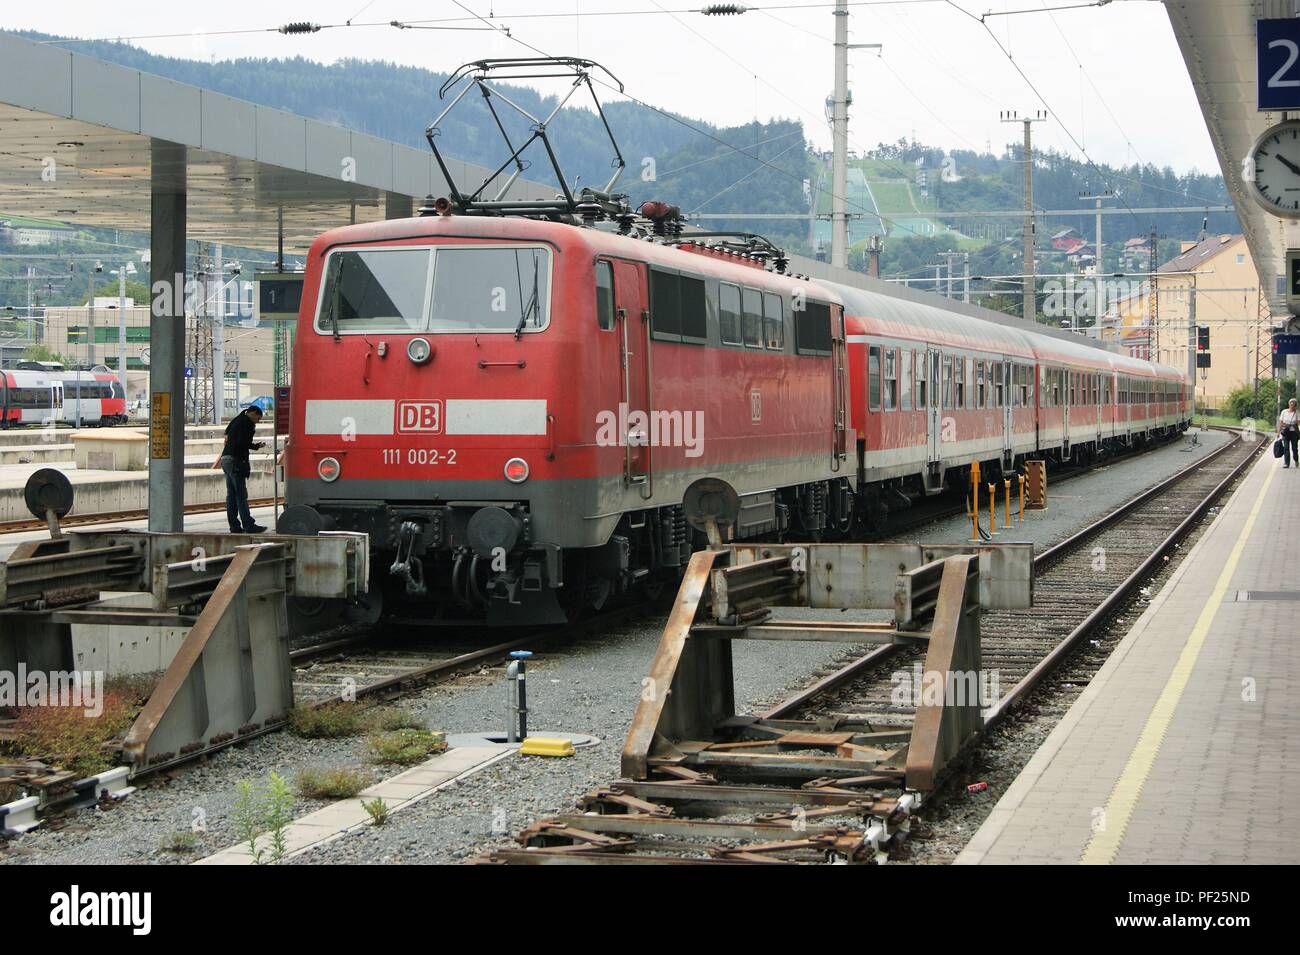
[611,260,653,488]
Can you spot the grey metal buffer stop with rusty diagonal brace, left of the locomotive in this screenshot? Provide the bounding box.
[0,472,369,773]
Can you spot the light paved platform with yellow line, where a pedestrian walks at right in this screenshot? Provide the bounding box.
[957,451,1300,864]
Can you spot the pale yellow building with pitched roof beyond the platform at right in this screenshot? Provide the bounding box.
[1099,235,1273,408]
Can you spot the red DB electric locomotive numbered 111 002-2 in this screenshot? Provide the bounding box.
[282,214,853,624]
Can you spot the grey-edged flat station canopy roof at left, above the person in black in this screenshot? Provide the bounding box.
[0,32,555,253]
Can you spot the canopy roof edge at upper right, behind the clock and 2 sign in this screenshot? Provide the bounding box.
[1165,0,1300,313]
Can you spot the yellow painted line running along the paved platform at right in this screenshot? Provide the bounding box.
[1079,468,1277,865]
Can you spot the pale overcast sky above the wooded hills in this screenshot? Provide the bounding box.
[17,0,1218,172]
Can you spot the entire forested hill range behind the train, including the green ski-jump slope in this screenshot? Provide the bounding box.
[0,32,1239,261]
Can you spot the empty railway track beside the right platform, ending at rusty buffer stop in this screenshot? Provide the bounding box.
[476,439,1264,864]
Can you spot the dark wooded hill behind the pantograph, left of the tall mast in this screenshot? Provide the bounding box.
[10,32,809,250]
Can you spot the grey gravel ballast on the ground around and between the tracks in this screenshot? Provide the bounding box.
[0,433,1227,864]
